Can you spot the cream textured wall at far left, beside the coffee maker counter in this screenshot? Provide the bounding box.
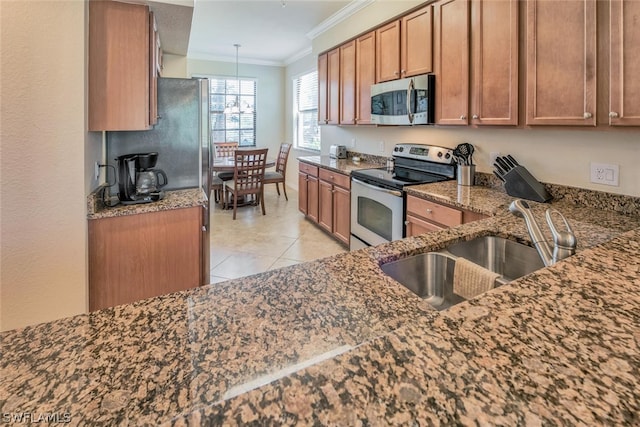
[0,0,90,330]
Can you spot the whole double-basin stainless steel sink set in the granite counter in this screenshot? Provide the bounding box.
[380,236,544,310]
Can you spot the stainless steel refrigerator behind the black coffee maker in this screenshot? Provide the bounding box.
[107,78,212,278]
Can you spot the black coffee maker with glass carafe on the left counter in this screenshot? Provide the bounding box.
[116,152,168,205]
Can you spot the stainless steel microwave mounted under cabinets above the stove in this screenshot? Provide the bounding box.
[371,74,436,125]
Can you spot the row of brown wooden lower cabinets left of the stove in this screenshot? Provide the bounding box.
[298,162,351,245]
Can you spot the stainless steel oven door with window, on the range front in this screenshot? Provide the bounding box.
[350,178,403,250]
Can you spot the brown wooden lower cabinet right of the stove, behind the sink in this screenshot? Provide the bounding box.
[405,195,487,237]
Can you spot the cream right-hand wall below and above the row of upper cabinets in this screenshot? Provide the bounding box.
[313,1,640,196]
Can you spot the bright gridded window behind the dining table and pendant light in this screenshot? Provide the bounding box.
[209,77,257,147]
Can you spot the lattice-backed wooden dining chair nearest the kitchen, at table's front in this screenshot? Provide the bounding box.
[224,148,268,220]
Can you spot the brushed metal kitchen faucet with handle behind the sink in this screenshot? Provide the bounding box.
[509,199,577,267]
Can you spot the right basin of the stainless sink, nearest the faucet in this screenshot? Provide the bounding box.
[445,236,544,284]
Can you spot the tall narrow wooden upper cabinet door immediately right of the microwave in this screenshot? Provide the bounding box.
[433,0,470,125]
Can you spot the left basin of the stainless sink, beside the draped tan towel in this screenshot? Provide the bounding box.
[381,252,465,310]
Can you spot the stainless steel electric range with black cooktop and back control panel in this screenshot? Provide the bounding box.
[349,144,456,250]
